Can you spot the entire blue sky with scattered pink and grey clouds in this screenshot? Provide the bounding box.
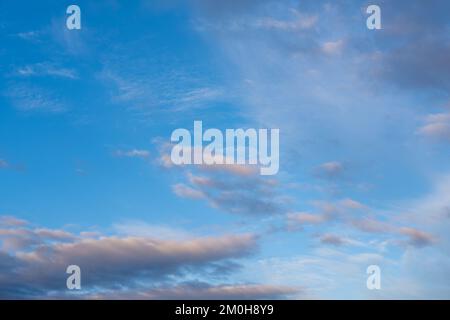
[0,0,450,299]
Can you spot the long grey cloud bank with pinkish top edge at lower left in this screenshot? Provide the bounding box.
[20,235,255,285]
